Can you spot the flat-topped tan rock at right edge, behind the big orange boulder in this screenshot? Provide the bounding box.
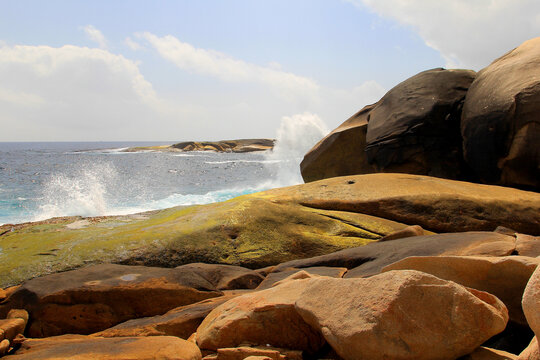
[382,256,540,325]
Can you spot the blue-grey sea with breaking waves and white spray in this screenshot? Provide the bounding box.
[0,114,326,224]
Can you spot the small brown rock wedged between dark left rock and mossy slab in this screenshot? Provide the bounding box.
[177,263,264,290]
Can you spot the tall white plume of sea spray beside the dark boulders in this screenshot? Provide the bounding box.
[263,112,328,188]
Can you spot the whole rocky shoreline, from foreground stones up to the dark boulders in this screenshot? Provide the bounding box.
[0,38,540,360]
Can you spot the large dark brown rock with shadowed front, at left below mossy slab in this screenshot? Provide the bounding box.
[0,264,222,337]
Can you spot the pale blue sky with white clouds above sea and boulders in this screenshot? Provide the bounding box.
[0,0,540,142]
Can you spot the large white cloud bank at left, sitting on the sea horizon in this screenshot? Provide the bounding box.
[0,45,175,141]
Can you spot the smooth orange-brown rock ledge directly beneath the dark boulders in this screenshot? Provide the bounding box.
[260,174,540,235]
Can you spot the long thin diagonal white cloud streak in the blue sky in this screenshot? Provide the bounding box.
[138,32,319,94]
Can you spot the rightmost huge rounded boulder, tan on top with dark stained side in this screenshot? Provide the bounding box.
[461,38,540,190]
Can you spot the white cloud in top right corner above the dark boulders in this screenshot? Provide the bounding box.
[345,0,540,70]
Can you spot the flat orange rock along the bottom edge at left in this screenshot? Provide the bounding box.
[6,335,202,360]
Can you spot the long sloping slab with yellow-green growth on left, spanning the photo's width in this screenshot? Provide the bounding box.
[0,174,540,286]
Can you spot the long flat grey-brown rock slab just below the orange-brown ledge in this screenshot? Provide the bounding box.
[274,232,515,278]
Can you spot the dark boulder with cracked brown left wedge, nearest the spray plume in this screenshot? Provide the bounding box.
[300,69,475,182]
